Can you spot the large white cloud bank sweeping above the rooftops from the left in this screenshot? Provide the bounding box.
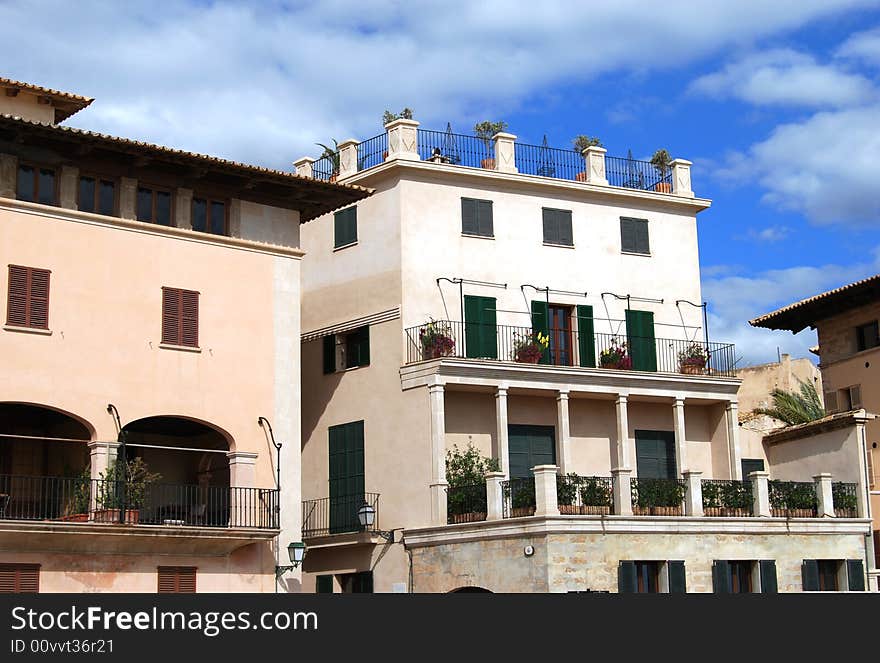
[0,0,872,166]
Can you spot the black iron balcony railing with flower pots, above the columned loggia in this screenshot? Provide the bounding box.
[406,320,736,377]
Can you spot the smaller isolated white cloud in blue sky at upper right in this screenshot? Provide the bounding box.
[690,49,877,107]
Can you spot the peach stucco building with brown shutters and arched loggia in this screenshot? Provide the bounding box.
[0,79,368,592]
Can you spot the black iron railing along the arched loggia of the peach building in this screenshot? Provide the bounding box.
[0,474,278,529]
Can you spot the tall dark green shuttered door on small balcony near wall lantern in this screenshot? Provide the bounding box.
[329,421,364,534]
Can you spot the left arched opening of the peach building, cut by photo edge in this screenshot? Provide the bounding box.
[0,403,93,520]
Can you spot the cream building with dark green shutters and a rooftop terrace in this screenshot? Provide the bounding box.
[296,119,869,592]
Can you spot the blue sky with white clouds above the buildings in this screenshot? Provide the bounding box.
[0,0,880,363]
